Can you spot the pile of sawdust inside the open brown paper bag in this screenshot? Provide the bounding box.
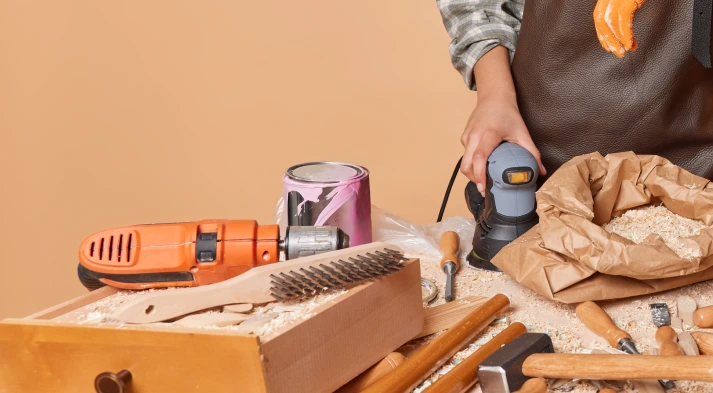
[603,205,706,260]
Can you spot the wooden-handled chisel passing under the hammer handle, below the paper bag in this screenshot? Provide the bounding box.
[575,302,676,389]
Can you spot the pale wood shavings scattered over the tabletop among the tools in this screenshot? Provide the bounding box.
[404,255,713,393]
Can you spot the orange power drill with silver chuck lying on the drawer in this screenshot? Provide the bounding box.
[77,220,349,289]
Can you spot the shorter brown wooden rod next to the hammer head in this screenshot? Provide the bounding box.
[423,322,527,393]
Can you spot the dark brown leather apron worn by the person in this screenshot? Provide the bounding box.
[513,0,713,180]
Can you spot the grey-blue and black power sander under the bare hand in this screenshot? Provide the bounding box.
[465,142,538,271]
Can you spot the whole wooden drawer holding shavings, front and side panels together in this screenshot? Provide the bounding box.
[0,260,423,393]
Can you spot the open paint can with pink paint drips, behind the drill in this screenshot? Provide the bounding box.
[283,162,372,246]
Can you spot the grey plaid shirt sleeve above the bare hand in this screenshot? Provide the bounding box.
[436,0,525,90]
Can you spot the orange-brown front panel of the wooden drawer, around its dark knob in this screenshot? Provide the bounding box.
[0,319,266,393]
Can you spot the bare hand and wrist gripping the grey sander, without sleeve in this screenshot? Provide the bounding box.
[461,46,546,195]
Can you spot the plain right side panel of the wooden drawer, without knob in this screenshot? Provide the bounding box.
[261,260,424,393]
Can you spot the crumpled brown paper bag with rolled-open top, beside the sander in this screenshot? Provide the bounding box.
[492,152,713,303]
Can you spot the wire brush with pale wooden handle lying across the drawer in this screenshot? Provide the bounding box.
[111,243,411,323]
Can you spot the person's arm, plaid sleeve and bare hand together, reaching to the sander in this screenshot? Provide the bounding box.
[437,0,545,193]
